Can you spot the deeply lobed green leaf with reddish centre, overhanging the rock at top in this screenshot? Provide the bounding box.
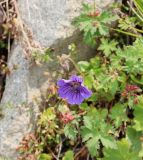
[74,5,117,47]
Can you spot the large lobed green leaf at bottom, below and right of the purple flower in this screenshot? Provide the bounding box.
[81,109,116,156]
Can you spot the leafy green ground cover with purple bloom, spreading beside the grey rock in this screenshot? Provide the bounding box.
[18,0,143,160]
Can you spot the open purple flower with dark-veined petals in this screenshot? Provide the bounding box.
[57,75,92,104]
